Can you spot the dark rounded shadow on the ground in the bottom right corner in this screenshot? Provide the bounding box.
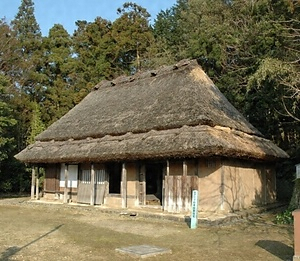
[255,240,294,261]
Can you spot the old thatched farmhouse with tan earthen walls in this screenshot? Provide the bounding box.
[16,60,288,211]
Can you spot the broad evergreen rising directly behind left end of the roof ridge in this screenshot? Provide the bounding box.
[73,17,117,92]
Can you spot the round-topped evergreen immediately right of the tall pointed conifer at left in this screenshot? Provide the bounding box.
[40,24,78,125]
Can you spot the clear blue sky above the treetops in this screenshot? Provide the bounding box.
[0,0,176,36]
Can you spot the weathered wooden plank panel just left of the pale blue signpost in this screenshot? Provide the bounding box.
[164,176,198,213]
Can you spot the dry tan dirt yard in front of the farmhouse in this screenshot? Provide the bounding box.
[0,197,293,261]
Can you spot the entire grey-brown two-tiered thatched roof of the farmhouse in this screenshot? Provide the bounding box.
[16,61,288,163]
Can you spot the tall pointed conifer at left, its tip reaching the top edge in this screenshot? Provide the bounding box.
[12,0,44,150]
